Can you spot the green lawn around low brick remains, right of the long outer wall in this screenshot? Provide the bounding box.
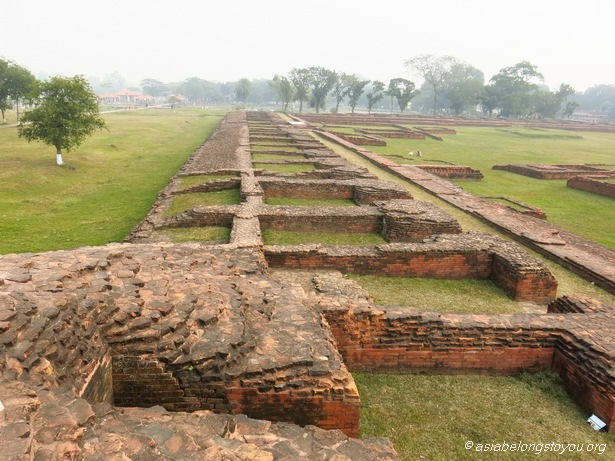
[370,127,615,249]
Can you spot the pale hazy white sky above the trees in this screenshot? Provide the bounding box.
[0,0,615,91]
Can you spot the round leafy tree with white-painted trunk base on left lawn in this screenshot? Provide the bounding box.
[18,75,106,165]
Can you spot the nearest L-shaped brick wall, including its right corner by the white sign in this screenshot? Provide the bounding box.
[292,272,615,431]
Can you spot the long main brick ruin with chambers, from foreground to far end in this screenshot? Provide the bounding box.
[0,112,615,460]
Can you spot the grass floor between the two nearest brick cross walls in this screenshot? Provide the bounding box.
[348,274,523,314]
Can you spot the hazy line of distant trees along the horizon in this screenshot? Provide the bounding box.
[0,54,615,121]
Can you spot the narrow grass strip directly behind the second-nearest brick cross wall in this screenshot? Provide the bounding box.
[263,229,386,245]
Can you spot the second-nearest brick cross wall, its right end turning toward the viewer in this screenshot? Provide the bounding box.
[265,234,557,303]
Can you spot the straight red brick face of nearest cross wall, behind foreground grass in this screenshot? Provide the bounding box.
[324,309,558,374]
